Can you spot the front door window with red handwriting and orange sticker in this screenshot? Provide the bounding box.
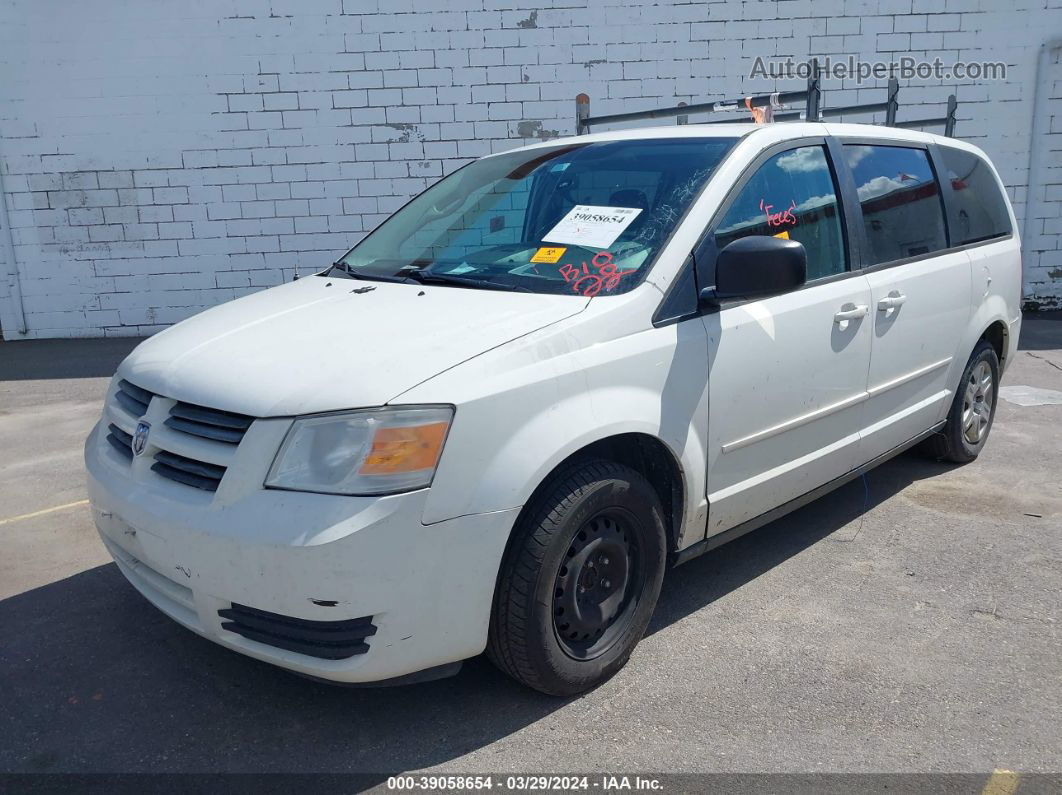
[716,146,845,281]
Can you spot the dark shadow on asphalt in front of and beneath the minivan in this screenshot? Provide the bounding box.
[0,455,945,780]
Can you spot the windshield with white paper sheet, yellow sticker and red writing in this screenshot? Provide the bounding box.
[325,138,736,296]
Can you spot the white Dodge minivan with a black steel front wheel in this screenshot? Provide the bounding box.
[85,122,1021,694]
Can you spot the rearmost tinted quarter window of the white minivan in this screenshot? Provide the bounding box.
[940,146,1011,245]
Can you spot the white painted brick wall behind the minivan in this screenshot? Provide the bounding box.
[0,0,1062,339]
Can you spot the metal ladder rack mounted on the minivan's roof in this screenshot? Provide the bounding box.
[576,58,959,138]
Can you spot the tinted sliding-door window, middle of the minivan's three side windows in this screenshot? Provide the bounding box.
[844,143,947,265]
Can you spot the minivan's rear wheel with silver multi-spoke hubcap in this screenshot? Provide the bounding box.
[922,340,999,464]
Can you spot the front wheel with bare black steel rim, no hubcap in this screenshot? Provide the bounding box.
[487,461,667,695]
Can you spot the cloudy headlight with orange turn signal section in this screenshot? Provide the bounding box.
[266,405,453,495]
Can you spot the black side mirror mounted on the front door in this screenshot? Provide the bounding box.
[701,235,807,299]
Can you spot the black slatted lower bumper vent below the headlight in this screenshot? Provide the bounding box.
[218,602,376,660]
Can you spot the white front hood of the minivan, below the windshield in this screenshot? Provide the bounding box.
[119,276,589,417]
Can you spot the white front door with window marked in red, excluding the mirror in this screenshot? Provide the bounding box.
[702,141,873,536]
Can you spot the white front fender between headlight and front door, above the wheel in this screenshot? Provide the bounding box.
[401,307,708,546]
